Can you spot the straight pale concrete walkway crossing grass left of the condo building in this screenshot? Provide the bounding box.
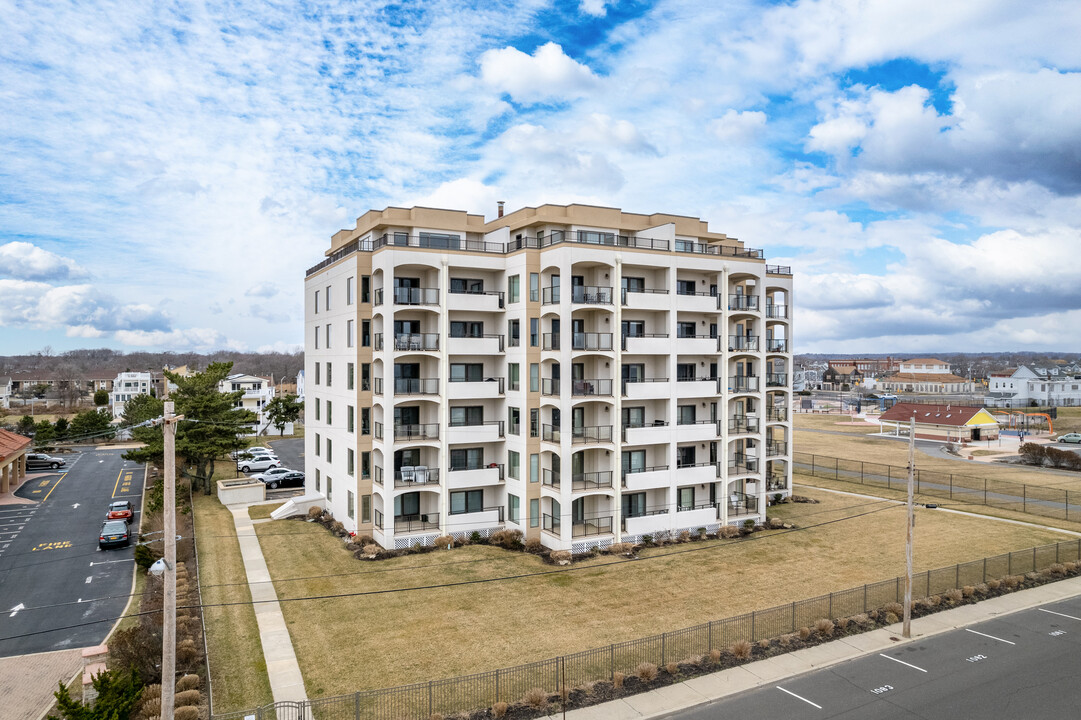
[228,505,308,703]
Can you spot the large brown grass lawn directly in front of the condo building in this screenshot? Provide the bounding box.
[256,491,1062,697]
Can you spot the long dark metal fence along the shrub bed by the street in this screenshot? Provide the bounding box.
[213,538,1081,720]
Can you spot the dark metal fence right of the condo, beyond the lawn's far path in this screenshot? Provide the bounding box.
[792,453,1081,521]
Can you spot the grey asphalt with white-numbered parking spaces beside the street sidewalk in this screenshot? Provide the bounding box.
[667,598,1081,720]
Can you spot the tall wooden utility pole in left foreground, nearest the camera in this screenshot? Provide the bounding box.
[161,402,184,720]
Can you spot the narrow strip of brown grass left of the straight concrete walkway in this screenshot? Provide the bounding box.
[195,493,272,712]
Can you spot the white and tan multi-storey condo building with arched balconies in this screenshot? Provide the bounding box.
[304,205,792,551]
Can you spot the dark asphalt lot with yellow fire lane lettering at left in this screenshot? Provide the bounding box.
[0,448,144,656]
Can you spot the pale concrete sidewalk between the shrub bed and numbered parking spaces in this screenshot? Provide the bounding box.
[566,577,1081,720]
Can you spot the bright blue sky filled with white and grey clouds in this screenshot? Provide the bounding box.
[0,0,1081,354]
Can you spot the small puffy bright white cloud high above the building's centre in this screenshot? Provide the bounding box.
[480,42,598,104]
